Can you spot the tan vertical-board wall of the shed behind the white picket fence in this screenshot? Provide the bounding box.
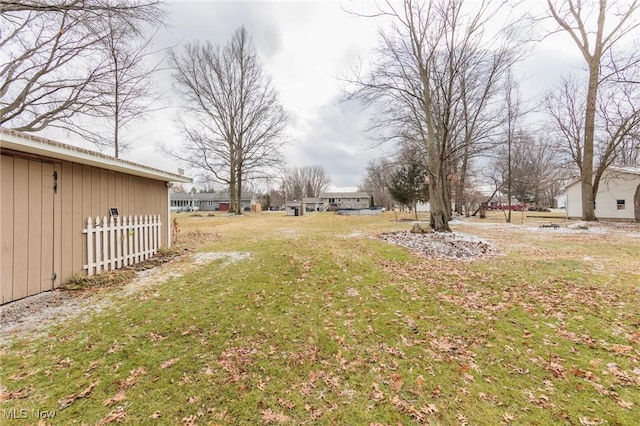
[0,152,169,303]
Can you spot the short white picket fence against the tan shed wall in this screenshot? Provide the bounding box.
[82,215,160,276]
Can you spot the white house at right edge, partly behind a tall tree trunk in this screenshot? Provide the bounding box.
[565,166,640,222]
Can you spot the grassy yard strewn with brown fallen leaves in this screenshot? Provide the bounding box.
[0,212,640,425]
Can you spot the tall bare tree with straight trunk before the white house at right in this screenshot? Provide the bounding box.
[547,0,640,220]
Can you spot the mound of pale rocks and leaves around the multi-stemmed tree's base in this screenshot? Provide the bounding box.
[378,231,500,260]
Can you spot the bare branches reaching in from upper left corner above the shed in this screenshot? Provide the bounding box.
[0,0,165,131]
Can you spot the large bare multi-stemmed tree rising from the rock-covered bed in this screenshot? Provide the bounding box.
[351,0,512,232]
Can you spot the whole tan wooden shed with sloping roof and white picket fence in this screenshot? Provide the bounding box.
[0,128,191,304]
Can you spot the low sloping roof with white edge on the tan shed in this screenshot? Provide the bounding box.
[0,128,192,183]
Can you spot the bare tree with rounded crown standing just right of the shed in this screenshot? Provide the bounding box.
[169,28,287,214]
